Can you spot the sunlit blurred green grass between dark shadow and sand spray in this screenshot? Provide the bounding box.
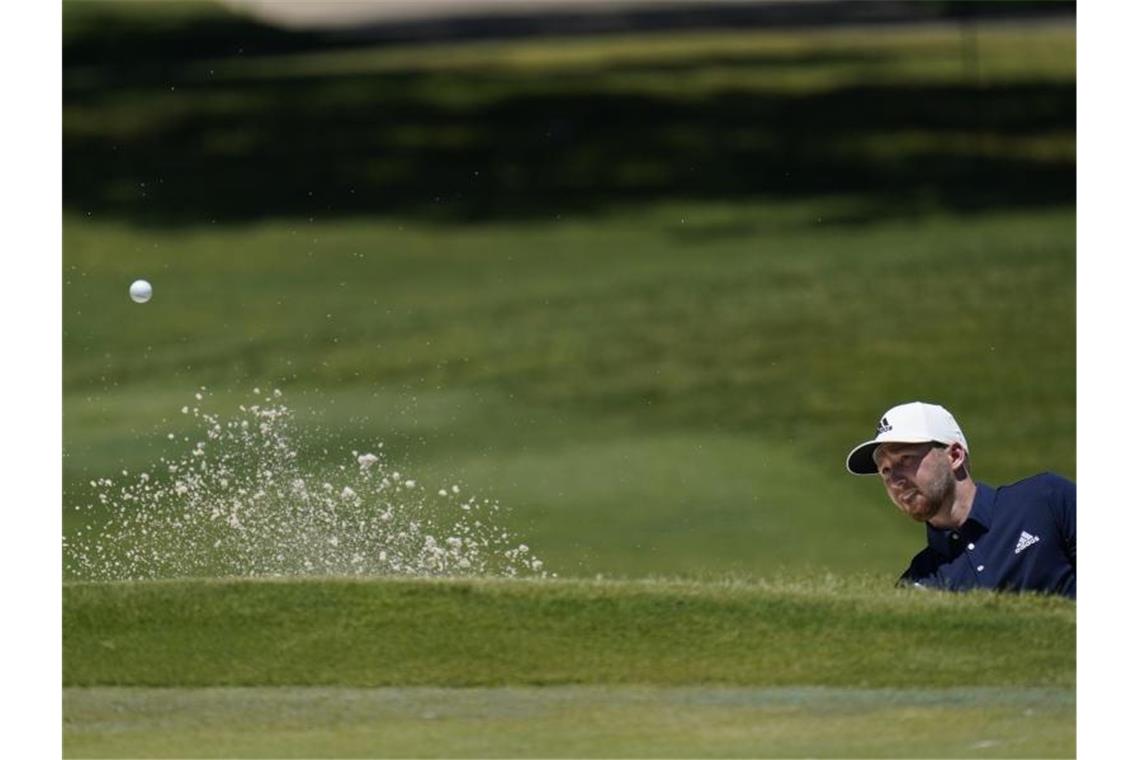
[64,199,1075,575]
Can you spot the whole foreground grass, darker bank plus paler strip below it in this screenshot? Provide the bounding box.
[64,579,1075,757]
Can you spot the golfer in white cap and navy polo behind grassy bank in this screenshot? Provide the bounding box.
[847,401,1076,599]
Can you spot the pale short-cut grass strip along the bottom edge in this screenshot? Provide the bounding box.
[64,686,1075,758]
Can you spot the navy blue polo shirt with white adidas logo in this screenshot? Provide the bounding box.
[899,473,1076,599]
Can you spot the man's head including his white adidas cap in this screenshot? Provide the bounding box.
[847,401,970,522]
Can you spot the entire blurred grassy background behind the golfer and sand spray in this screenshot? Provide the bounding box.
[63,0,1076,582]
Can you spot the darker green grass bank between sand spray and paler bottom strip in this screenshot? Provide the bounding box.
[64,579,1075,688]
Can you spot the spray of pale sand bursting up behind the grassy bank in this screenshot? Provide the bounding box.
[63,389,553,580]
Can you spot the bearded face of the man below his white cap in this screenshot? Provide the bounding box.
[874,443,955,522]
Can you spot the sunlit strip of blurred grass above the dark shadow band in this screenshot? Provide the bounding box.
[205,24,1076,104]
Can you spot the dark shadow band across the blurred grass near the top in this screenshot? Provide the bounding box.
[64,3,1076,224]
